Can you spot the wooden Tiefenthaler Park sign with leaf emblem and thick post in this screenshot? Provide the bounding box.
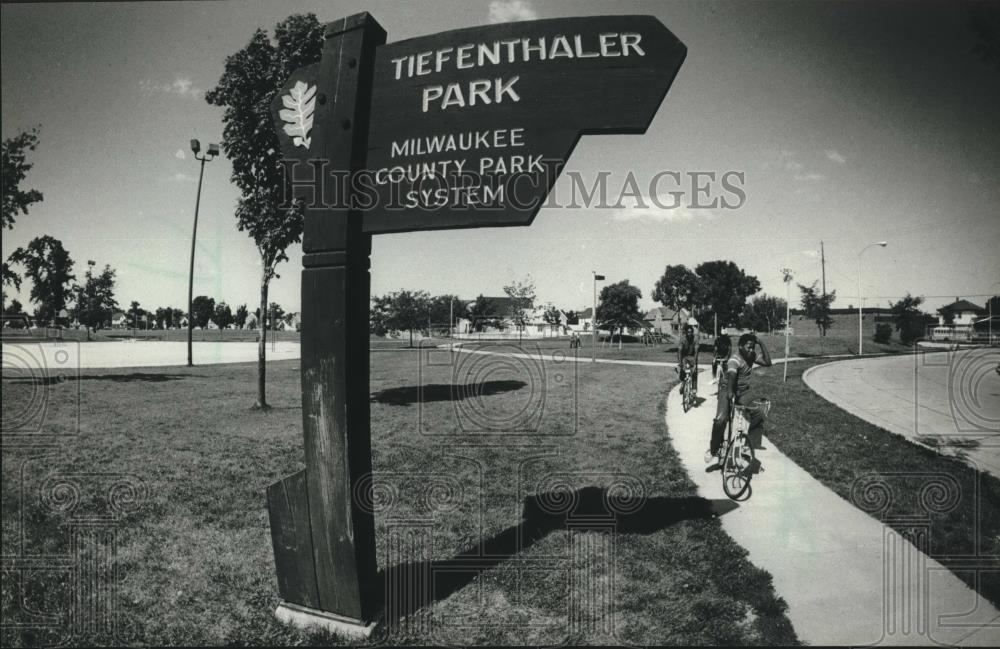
[268,13,687,631]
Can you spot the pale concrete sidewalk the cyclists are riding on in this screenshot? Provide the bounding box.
[666,376,1000,646]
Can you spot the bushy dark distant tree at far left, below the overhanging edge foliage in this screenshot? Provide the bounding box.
[10,235,76,323]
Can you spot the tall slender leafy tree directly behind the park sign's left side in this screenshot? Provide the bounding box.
[205,14,324,409]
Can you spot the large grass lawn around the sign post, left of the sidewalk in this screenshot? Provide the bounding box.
[2,351,797,646]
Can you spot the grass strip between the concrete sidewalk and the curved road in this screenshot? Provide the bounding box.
[753,360,1000,606]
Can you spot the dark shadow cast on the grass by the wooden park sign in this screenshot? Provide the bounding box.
[379,487,739,627]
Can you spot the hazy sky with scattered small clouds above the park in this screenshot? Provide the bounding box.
[0,0,1000,311]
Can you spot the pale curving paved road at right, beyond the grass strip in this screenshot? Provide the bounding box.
[802,348,1000,477]
